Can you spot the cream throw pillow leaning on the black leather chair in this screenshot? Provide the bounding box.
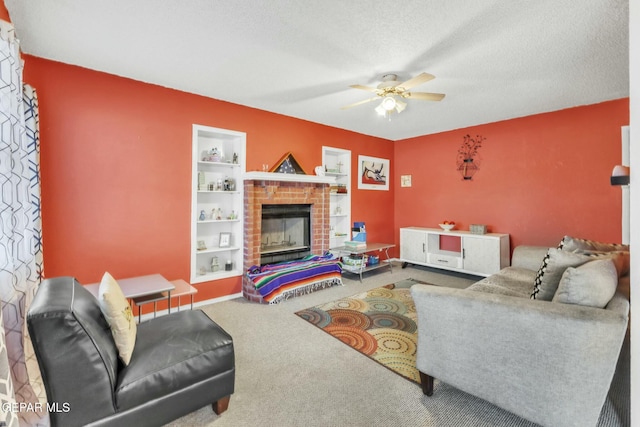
[98,273,138,366]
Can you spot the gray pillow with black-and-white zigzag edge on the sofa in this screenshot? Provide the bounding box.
[531,248,593,301]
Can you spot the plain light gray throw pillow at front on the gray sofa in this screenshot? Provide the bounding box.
[552,259,618,308]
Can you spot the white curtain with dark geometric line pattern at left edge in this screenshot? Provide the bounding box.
[0,21,46,425]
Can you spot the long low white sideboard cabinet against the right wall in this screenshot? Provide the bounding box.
[400,227,510,276]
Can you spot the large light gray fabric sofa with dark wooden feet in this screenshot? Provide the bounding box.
[411,246,629,427]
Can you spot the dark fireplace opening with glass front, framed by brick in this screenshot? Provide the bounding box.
[260,204,311,265]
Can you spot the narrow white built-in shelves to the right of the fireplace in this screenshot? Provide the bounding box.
[322,146,351,248]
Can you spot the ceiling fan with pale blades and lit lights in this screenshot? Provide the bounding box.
[342,73,445,115]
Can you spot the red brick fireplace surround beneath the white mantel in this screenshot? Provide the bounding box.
[242,174,330,303]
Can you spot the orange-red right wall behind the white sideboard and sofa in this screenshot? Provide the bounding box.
[394,98,629,248]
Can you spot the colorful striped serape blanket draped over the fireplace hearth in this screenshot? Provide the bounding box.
[247,253,342,304]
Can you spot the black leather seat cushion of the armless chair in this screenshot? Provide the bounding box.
[115,310,235,412]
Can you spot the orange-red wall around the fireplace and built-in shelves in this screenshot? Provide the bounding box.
[25,55,394,308]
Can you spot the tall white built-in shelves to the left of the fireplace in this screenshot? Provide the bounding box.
[191,124,246,283]
